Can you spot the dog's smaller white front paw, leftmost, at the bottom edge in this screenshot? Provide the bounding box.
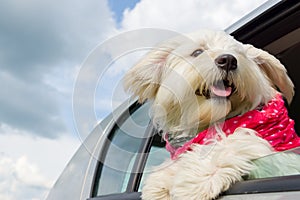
[142,160,177,200]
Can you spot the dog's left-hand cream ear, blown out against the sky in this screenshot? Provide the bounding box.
[124,41,178,103]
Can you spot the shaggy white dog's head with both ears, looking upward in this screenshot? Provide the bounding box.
[124,30,294,136]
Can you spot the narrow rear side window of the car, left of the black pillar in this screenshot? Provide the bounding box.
[93,103,150,196]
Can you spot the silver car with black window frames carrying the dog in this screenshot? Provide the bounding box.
[47,0,300,200]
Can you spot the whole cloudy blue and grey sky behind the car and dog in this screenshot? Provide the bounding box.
[0,0,265,200]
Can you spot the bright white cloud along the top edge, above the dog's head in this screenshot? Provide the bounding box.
[122,0,266,33]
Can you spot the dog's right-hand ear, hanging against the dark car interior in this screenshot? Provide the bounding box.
[245,45,294,103]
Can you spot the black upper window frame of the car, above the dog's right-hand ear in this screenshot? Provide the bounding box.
[225,0,300,48]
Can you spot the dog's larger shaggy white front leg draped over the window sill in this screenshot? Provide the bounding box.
[171,129,273,200]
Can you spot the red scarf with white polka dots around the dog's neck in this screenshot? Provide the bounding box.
[166,94,300,159]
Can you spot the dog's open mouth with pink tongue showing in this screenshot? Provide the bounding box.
[195,80,235,99]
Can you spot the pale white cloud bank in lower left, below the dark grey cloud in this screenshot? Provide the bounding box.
[0,124,80,200]
